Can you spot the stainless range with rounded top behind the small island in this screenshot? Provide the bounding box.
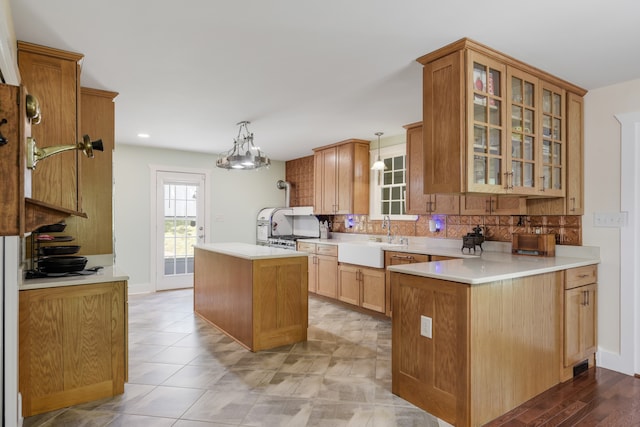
[256,207,320,250]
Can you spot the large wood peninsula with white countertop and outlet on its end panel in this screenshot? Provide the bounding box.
[388,252,599,427]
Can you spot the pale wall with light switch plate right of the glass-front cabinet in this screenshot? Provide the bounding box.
[583,79,640,366]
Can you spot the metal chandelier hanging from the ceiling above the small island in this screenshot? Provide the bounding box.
[216,120,271,169]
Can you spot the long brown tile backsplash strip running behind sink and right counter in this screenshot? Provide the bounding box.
[331,215,582,246]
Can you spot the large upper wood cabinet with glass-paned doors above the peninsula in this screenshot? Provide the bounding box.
[418,39,586,201]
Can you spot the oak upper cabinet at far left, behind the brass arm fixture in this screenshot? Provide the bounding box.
[18,42,82,212]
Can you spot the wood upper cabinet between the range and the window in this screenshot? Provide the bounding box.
[313,139,369,215]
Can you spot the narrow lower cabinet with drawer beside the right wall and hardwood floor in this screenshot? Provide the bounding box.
[562,265,598,381]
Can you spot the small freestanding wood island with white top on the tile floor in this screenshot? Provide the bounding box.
[193,243,309,352]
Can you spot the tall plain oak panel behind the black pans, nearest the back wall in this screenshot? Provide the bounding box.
[65,87,118,255]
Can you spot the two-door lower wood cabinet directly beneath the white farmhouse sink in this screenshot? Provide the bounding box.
[338,264,386,313]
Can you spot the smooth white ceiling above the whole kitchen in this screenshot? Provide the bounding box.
[11,0,640,160]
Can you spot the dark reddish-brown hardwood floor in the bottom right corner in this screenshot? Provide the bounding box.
[487,368,640,427]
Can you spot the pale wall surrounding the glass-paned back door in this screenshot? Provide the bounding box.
[113,144,285,292]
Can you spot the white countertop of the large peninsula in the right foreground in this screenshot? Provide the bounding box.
[387,252,600,285]
